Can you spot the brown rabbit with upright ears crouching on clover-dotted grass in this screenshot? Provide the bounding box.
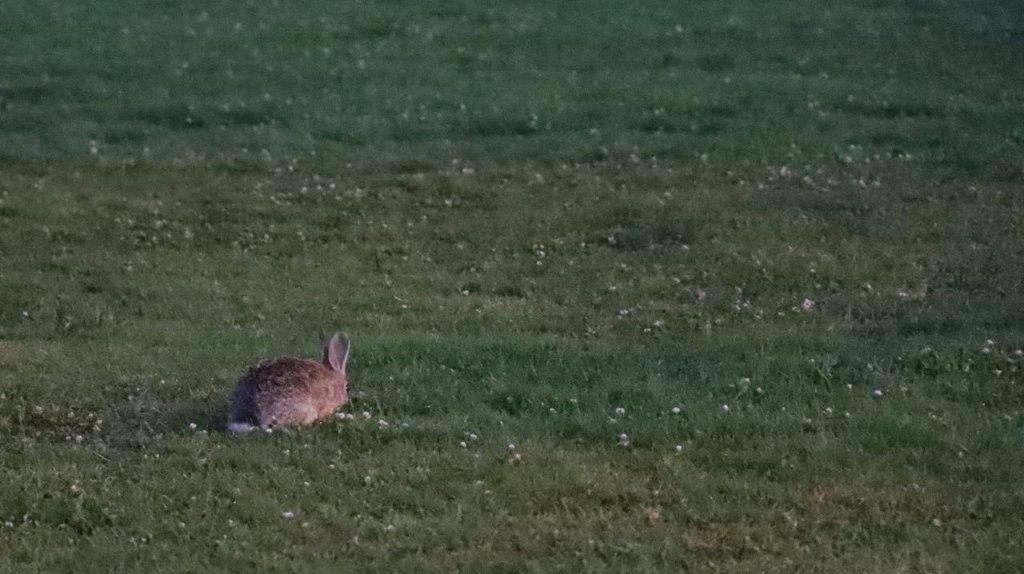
[227,334,349,433]
